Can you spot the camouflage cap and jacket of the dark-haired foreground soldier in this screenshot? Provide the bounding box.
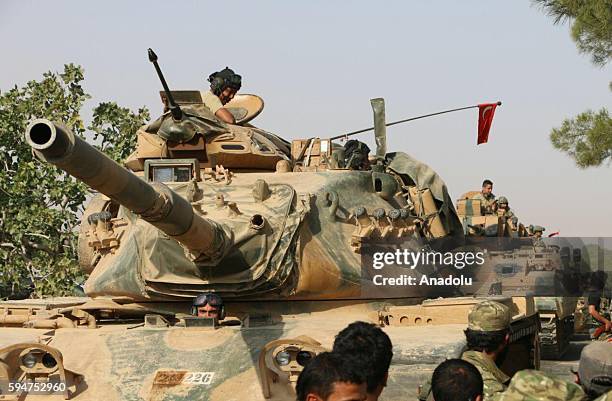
[461,301,511,400]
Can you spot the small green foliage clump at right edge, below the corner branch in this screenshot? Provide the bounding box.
[550,108,612,168]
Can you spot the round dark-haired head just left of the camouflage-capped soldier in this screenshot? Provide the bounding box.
[431,359,483,401]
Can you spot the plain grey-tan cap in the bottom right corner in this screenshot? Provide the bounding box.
[578,342,612,395]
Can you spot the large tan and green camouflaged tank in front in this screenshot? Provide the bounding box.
[0,50,539,400]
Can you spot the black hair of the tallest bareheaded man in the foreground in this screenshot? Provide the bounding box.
[334,322,393,393]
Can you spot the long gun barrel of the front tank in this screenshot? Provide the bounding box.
[25,119,227,259]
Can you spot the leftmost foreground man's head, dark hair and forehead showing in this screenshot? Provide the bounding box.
[295,352,366,401]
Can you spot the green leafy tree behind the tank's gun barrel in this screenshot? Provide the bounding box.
[0,64,149,297]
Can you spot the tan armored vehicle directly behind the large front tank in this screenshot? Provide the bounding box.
[457,191,583,359]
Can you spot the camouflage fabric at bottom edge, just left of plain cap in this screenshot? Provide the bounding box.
[494,369,585,401]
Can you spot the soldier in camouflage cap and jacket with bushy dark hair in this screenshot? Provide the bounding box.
[461,301,512,401]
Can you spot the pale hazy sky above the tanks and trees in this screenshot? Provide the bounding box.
[0,0,612,236]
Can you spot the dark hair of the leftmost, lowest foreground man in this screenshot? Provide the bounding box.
[295,352,365,401]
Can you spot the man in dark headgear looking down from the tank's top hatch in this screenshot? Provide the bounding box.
[202,67,242,124]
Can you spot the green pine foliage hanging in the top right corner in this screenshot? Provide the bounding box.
[532,0,612,66]
